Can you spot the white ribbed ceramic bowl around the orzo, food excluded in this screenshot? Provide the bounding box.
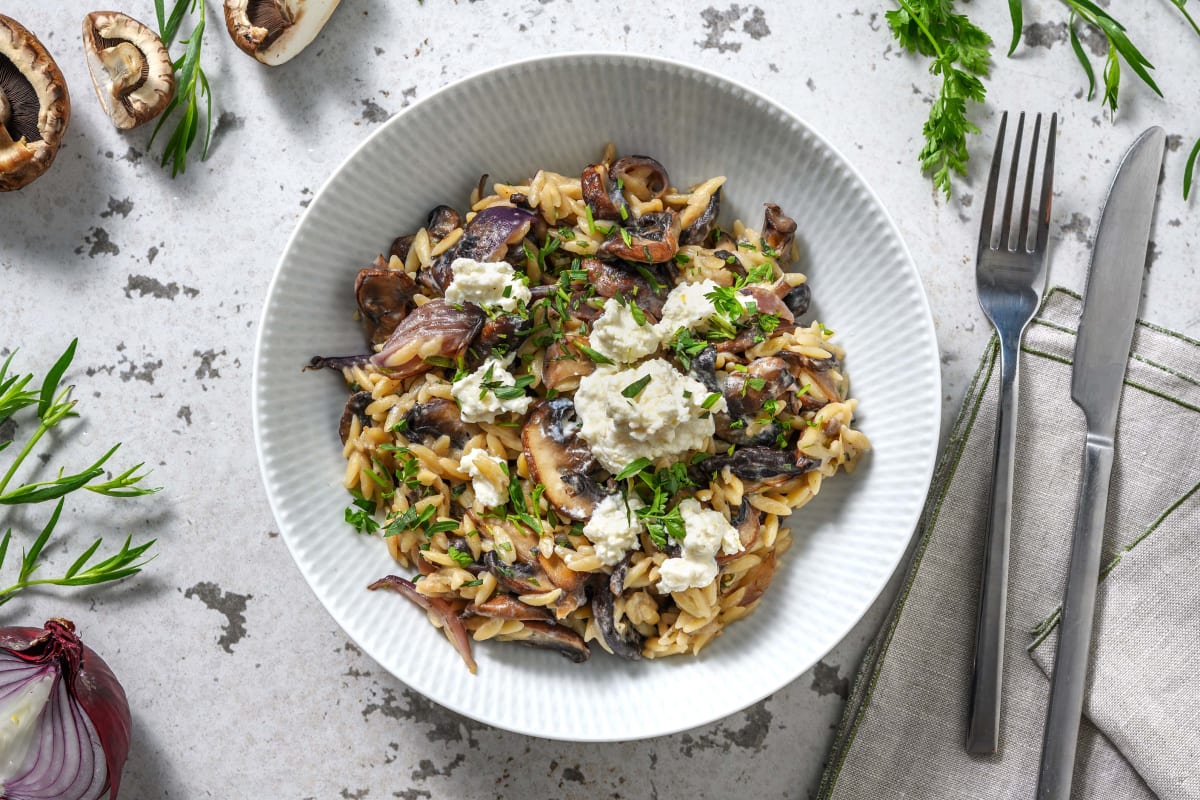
[253,54,941,741]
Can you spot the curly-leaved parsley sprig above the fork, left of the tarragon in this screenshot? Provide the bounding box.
[886,0,991,198]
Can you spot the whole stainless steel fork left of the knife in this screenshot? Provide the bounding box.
[967,112,1058,753]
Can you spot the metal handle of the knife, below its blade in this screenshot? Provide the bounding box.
[1037,432,1112,800]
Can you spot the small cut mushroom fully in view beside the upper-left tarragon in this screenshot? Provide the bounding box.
[83,11,175,131]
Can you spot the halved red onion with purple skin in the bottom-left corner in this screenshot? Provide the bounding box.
[0,619,132,800]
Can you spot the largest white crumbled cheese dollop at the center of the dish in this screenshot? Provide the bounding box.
[571,359,725,473]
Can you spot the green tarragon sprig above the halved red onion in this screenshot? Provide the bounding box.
[0,341,158,604]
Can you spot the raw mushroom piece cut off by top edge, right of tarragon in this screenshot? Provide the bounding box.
[224,0,338,67]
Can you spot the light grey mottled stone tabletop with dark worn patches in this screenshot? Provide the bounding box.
[0,0,1200,800]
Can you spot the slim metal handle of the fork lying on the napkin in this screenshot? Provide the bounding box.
[966,331,1021,753]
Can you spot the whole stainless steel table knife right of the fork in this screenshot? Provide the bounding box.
[1037,127,1166,800]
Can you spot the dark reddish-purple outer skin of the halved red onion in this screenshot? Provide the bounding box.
[0,618,133,800]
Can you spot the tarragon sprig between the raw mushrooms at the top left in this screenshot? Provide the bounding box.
[150,0,212,178]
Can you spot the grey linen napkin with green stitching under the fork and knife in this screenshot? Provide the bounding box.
[820,288,1200,800]
